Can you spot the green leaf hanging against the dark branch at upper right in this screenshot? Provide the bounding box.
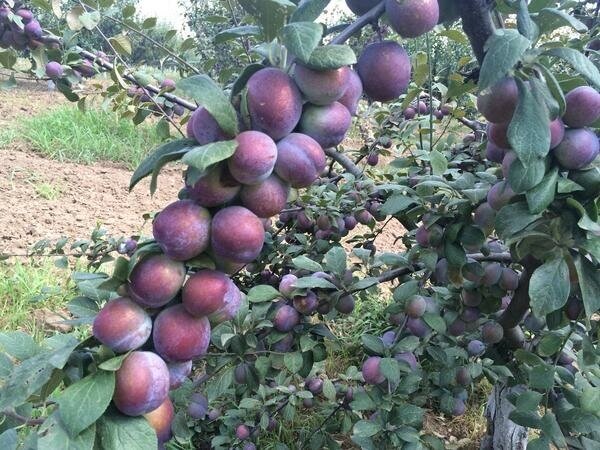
[479,29,531,90]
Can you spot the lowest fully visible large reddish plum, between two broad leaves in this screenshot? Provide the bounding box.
[113,351,169,416]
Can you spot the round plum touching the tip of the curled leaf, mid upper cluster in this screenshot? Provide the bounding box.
[228,130,277,184]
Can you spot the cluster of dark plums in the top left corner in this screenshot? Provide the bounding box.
[0,2,42,50]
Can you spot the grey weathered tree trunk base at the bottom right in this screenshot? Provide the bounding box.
[480,382,527,450]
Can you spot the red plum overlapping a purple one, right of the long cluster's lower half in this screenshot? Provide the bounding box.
[181,269,239,317]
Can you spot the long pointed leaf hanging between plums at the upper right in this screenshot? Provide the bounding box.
[508,78,550,167]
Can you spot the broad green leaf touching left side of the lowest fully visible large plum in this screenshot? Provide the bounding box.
[58,370,115,436]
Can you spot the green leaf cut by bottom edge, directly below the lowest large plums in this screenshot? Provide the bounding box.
[97,413,158,450]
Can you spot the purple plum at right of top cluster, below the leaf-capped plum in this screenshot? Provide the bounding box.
[298,102,352,148]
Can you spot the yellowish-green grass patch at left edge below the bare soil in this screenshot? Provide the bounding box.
[0,258,75,338]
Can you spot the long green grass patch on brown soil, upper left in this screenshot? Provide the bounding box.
[6,105,160,169]
